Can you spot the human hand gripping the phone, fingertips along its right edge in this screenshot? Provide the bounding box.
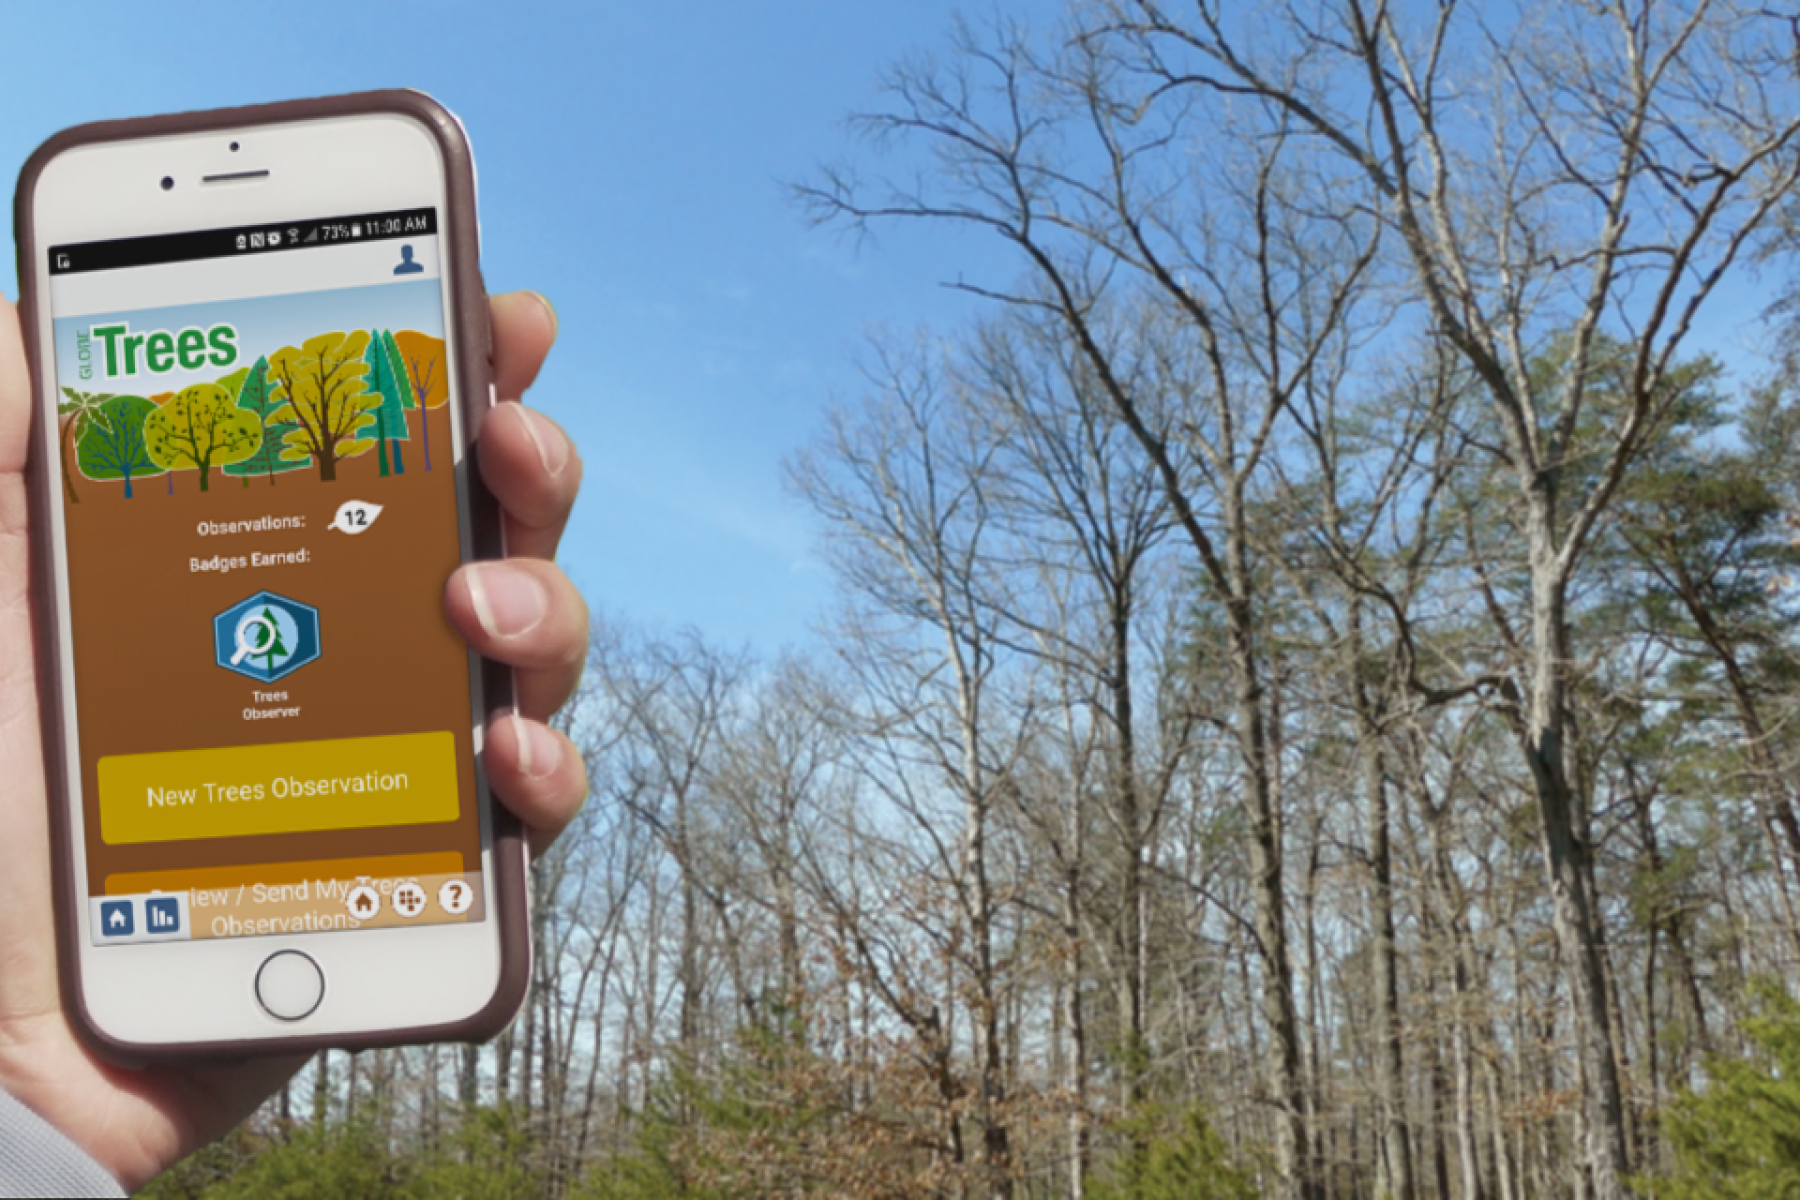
[0,284,587,1189]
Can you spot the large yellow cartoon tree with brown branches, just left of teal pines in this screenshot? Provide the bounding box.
[268,333,382,484]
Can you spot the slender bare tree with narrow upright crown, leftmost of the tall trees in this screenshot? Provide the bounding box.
[792,340,1026,1196]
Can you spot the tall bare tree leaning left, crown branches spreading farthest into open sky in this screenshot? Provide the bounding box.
[803,21,1377,1200]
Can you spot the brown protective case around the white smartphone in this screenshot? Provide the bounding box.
[13,90,531,1063]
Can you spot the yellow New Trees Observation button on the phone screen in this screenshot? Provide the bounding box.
[99,732,457,846]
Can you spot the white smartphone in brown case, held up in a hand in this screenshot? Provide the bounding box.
[14,92,529,1060]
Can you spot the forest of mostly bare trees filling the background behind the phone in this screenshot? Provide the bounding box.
[146,0,1800,1200]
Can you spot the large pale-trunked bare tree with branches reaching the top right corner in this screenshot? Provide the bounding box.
[1080,0,1800,1200]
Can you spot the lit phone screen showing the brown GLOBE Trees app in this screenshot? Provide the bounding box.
[49,209,484,946]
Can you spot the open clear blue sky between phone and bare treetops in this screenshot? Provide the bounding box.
[0,0,1036,651]
